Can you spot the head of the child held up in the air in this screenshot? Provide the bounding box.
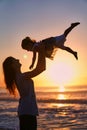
[21,37,36,51]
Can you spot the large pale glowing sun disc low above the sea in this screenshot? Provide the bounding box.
[48,62,74,86]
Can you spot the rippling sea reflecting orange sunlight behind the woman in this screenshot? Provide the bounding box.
[0,86,87,130]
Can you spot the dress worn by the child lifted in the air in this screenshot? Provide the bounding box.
[33,35,66,60]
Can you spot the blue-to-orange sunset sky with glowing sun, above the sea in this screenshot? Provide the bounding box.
[0,0,87,86]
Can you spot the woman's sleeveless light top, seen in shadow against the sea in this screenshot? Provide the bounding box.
[16,73,38,116]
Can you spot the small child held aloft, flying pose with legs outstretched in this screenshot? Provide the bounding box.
[21,22,80,69]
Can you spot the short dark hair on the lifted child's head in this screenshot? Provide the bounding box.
[21,37,36,49]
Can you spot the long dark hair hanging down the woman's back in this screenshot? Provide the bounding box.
[3,56,16,95]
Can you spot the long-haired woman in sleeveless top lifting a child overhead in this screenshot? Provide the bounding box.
[3,45,45,130]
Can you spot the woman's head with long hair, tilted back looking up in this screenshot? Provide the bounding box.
[3,56,21,94]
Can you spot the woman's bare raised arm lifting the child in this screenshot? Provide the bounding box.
[24,44,46,78]
